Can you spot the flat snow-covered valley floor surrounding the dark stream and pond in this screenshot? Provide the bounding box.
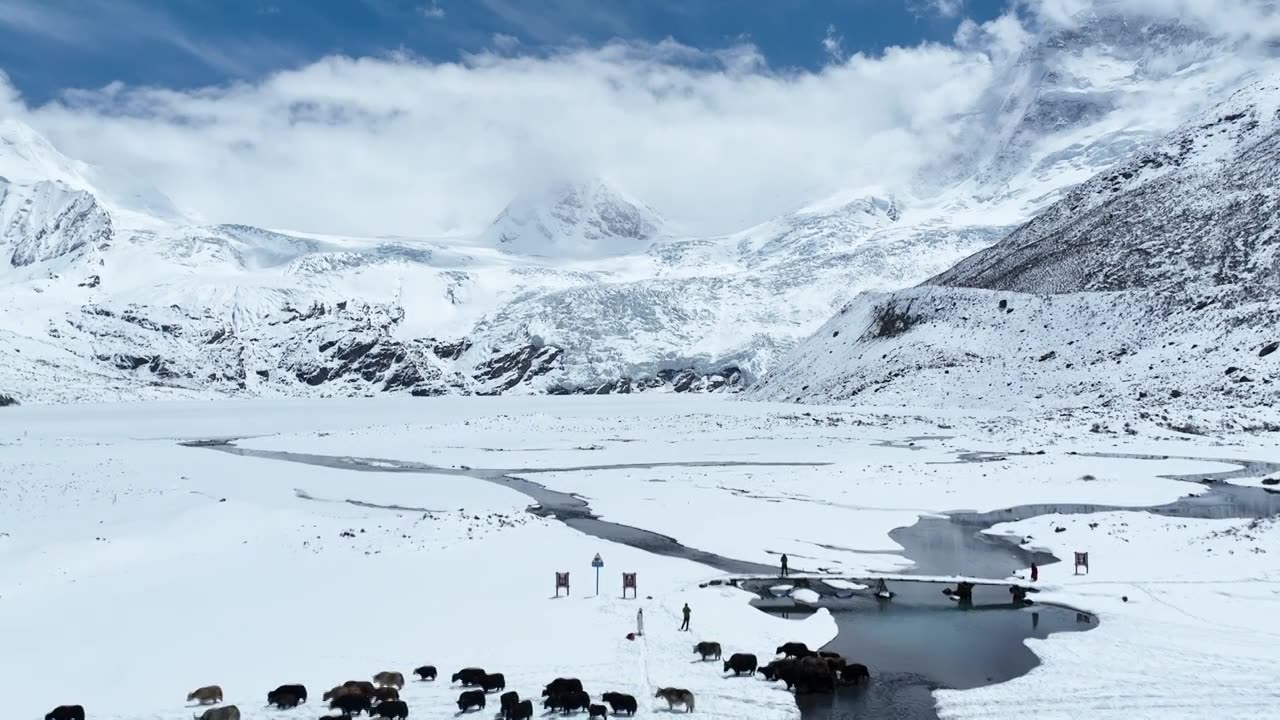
[0,396,1280,720]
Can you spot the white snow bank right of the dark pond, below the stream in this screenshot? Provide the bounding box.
[934,512,1280,720]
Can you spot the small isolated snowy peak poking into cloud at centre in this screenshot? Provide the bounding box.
[485,178,663,258]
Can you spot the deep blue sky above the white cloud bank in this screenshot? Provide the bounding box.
[0,0,1007,105]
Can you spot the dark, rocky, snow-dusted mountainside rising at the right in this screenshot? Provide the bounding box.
[753,76,1280,413]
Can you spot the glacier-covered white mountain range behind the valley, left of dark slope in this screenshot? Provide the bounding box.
[0,9,1263,402]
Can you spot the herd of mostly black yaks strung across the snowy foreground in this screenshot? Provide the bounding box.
[45,642,870,720]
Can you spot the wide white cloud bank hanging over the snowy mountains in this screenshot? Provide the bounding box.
[0,0,1267,234]
